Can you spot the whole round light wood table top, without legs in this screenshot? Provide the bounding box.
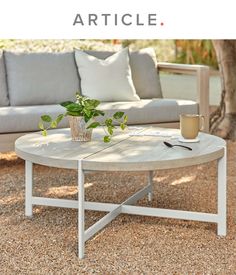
[15,126,226,171]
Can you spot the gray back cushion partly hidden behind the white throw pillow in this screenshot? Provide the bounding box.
[85,48,162,99]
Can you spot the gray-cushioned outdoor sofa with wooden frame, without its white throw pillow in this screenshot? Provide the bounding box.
[0,48,209,152]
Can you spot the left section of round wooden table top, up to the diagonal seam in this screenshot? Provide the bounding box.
[15,129,129,169]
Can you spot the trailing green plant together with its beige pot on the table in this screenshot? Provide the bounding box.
[39,93,128,142]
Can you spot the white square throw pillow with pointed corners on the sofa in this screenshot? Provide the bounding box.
[75,48,140,101]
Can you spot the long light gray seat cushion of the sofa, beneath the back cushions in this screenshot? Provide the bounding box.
[0,99,198,133]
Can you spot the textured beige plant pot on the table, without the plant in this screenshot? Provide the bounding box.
[68,116,93,141]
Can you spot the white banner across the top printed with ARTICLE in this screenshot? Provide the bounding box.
[0,0,236,39]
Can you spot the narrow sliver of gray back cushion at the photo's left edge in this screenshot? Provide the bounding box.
[0,53,9,106]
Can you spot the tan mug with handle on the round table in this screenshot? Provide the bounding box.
[180,114,204,139]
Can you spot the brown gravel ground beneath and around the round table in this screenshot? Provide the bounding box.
[0,142,236,274]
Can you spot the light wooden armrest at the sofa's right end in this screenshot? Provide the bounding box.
[157,62,209,132]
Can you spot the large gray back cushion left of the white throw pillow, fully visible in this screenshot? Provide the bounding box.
[4,52,79,106]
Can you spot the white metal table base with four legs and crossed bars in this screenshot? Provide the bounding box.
[25,150,226,259]
